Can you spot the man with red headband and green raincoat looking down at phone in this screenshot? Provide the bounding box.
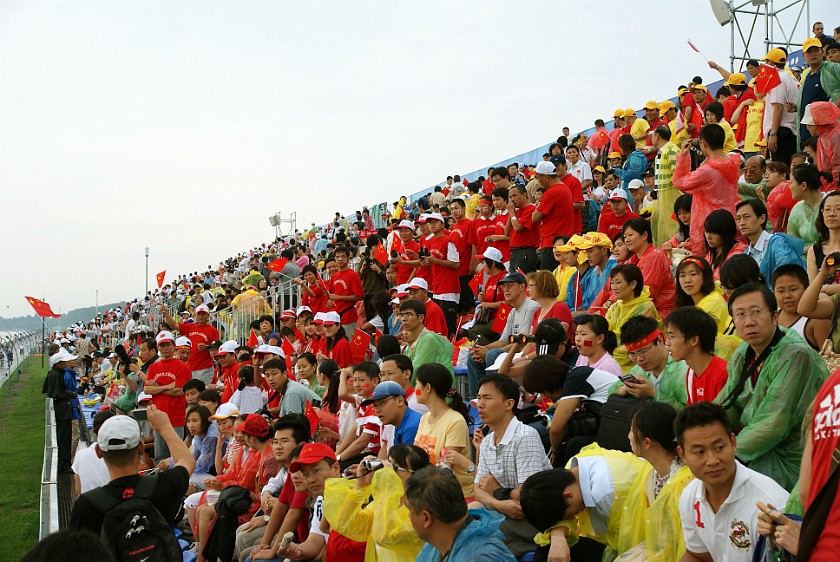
[610,316,688,402]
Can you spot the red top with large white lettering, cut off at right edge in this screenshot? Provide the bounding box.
[804,370,840,562]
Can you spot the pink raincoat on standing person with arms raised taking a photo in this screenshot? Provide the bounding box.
[674,152,741,256]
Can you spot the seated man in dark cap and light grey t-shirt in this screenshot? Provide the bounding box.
[466,271,540,399]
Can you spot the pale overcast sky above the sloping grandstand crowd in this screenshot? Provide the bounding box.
[0,0,828,317]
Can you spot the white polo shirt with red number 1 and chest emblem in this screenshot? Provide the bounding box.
[680,461,789,562]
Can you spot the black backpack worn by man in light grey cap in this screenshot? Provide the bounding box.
[85,476,183,562]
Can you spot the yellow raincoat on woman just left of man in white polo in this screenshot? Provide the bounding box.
[618,464,694,562]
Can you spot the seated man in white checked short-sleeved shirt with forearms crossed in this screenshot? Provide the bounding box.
[474,375,551,556]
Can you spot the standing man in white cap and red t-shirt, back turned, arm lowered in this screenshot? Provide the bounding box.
[531,159,575,271]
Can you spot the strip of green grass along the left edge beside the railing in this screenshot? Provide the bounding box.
[0,357,49,561]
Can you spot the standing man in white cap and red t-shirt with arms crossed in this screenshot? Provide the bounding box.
[143,331,190,462]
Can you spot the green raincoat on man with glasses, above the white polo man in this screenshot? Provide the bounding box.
[715,328,828,490]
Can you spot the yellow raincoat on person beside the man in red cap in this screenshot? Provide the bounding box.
[324,467,424,562]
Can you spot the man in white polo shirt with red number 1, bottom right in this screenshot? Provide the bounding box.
[674,402,788,562]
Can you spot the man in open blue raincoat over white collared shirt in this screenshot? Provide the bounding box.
[735,199,805,286]
